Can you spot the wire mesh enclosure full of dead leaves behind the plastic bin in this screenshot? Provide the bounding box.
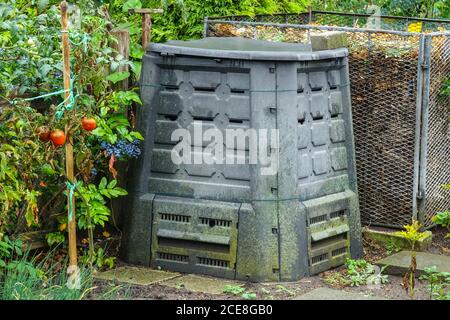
[205,11,450,227]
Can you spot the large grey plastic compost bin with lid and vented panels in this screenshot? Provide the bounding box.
[122,38,361,281]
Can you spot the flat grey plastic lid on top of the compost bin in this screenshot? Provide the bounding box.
[147,37,348,61]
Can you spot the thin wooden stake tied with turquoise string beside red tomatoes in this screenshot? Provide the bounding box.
[60,1,77,267]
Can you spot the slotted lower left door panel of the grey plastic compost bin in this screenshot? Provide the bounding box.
[151,196,240,278]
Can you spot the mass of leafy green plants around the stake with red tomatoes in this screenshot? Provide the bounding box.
[0,0,139,245]
